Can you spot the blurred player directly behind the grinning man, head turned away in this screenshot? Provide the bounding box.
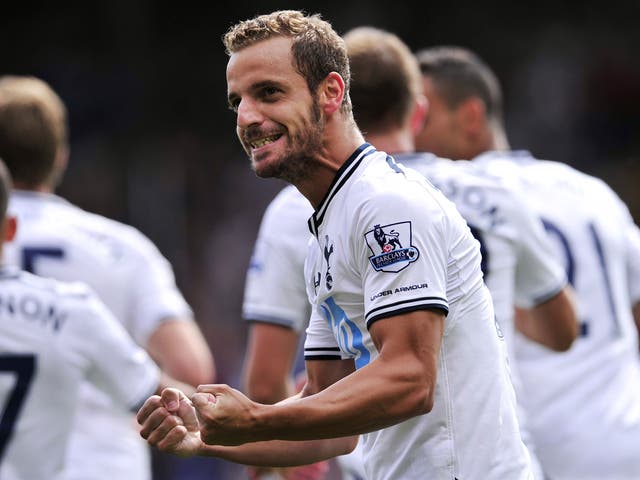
[344,27,578,478]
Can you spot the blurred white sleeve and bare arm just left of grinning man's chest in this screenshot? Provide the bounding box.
[242,182,365,480]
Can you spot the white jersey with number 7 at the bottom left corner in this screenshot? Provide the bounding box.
[0,267,159,480]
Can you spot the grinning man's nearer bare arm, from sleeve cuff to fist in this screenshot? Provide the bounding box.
[198,310,444,445]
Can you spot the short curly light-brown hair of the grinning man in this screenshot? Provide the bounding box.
[223,10,351,111]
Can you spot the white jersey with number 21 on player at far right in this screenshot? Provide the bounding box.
[474,152,640,479]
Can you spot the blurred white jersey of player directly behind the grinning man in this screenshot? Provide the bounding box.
[395,153,567,476]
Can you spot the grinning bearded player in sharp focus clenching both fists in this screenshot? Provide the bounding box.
[138,10,532,480]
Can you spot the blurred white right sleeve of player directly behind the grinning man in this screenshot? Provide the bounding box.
[511,192,567,308]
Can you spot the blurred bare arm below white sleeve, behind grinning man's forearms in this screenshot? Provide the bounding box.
[243,322,299,404]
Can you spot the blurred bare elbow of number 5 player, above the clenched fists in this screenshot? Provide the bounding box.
[147,319,215,386]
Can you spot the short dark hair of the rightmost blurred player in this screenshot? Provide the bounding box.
[416,46,503,124]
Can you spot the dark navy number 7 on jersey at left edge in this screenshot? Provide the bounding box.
[0,354,36,463]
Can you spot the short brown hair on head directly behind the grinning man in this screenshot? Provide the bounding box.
[344,27,422,133]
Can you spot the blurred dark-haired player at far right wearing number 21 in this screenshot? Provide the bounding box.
[417,47,640,480]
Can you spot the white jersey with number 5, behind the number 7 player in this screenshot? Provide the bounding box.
[5,190,192,480]
